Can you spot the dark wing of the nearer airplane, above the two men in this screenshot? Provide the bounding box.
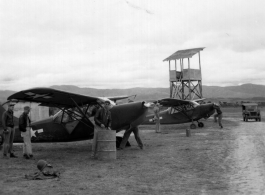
[7,88,98,108]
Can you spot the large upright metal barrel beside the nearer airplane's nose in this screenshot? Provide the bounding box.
[97,130,116,160]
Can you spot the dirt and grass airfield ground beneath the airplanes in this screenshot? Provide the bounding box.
[0,108,265,195]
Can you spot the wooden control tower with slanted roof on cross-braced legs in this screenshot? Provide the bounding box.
[163,47,204,100]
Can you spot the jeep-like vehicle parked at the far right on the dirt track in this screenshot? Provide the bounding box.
[242,103,261,122]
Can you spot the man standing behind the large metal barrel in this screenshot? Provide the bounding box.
[92,100,111,158]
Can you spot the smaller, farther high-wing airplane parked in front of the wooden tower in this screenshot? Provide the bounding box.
[143,98,215,129]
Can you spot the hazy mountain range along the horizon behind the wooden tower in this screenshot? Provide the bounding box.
[0,84,265,102]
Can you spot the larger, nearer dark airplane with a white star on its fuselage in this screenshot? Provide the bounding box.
[0,88,147,145]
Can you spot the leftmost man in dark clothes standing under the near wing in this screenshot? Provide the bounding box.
[2,102,17,158]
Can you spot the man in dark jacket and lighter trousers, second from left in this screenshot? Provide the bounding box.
[19,106,33,159]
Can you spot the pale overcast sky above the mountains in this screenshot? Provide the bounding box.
[0,0,265,91]
